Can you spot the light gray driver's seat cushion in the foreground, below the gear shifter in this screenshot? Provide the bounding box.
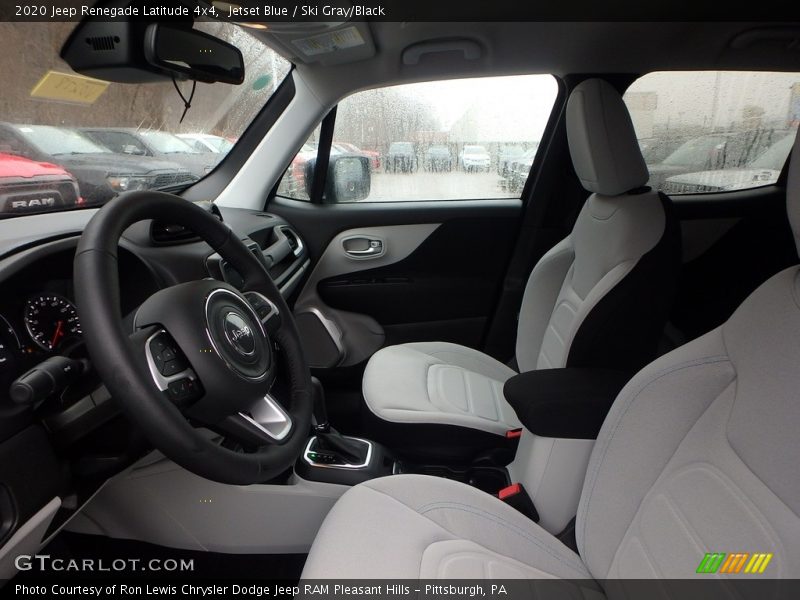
[302,475,599,592]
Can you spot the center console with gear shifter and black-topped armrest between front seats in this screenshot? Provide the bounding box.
[295,368,629,534]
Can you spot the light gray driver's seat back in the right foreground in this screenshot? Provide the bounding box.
[576,130,800,580]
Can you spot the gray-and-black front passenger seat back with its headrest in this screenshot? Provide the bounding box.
[516,79,680,371]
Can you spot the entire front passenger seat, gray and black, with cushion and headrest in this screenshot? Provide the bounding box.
[363,79,681,454]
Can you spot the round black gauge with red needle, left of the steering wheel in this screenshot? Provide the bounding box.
[24,294,81,351]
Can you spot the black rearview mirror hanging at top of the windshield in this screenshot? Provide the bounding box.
[144,23,244,85]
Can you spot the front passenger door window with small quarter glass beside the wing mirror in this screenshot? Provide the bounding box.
[278,75,558,202]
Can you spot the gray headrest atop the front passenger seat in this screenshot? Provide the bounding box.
[567,79,650,196]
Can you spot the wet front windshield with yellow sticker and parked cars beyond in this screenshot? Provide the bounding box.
[0,21,291,218]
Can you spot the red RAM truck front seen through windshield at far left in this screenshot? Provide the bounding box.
[0,148,83,215]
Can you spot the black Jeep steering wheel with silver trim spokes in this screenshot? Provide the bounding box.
[74,192,313,485]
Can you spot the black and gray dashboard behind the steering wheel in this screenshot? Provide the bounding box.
[0,207,310,545]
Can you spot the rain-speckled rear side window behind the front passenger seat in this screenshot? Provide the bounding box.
[625,71,800,195]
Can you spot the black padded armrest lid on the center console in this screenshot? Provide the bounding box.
[503,367,632,439]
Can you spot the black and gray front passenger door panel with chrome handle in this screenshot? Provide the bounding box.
[269,198,521,369]
